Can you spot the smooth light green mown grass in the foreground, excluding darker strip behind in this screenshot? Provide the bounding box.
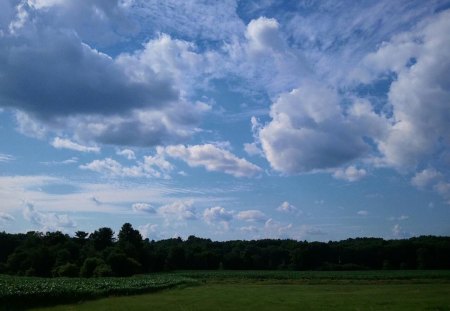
[29,282,450,311]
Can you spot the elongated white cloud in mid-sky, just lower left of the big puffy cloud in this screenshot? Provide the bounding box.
[165,144,262,177]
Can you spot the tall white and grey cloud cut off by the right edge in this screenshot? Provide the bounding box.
[364,10,450,169]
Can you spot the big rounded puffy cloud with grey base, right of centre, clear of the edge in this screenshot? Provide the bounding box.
[259,83,369,174]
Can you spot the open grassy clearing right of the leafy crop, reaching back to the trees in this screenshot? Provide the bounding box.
[22,271,450,311]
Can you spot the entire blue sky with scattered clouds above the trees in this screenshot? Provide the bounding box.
[0,0,450,241]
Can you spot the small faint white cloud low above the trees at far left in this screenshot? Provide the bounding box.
[23,203,77,231]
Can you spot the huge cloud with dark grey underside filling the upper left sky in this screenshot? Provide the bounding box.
[0,0,209,149]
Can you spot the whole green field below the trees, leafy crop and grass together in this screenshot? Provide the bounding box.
[0,271,450,311]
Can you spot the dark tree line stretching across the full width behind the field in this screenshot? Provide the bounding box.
[0,223,450,277]
